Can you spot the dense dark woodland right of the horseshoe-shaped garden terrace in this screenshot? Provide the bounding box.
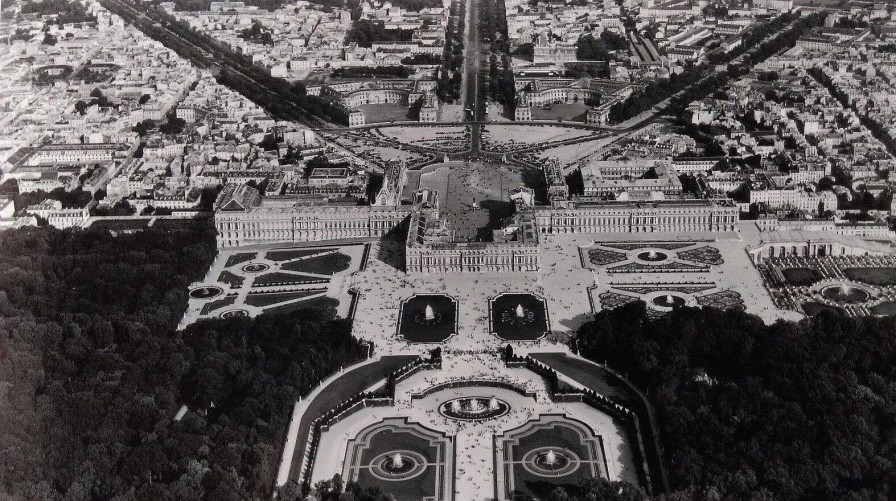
[570,302,896,499]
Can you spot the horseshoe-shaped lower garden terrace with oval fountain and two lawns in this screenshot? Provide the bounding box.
[290,350,658,501]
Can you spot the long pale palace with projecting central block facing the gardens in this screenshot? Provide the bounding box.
[215,179,738,273]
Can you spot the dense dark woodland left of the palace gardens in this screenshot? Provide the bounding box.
[0,223,367,500]
